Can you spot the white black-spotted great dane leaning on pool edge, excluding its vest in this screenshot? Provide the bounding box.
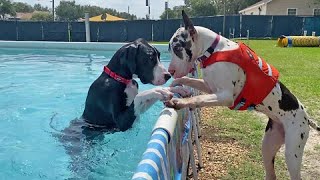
[166,12,320,180]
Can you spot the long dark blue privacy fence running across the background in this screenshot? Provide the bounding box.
[0,15,320,42]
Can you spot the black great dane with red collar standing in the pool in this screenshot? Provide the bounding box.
[82,39,190,131]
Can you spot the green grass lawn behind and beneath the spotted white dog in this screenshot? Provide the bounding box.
[202,40,320,180]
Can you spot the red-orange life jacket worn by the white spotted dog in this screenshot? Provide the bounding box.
[201,42,279,110]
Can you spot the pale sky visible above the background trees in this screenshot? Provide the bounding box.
[13,0,184,19]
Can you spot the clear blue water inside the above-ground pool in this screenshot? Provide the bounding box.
[0,49,169,180]
